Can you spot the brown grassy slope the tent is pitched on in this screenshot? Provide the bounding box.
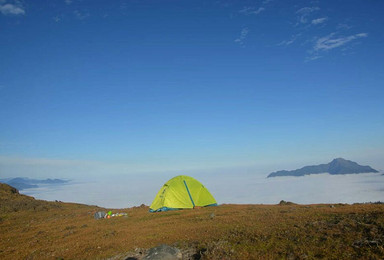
[0,186,384,259]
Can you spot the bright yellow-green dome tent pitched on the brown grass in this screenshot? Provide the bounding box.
[149,175,217,212]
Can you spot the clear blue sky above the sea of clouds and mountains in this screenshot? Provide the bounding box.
[0,0,384,177]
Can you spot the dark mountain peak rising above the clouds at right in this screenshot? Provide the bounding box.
[268,158,378,178]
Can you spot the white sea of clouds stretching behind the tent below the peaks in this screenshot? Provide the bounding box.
[22,173,384,208]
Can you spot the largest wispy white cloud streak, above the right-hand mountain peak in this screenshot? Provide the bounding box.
[313,33,368,52]
